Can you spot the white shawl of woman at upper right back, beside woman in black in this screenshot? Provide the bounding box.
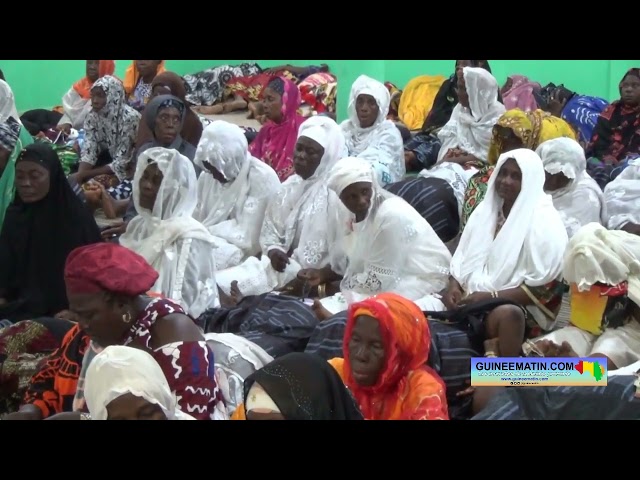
[437,67,506,163]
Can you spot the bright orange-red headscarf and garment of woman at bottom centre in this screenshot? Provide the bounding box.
[342,293,449,420]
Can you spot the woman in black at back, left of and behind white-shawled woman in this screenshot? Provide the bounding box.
[404,60,501,172]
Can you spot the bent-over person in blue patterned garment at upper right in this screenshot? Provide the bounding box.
[536,83,609,148]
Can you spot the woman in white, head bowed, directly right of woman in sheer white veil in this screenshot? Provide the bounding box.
[193,120,280,270]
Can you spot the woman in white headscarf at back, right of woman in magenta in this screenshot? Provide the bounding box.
[340,75,406,187]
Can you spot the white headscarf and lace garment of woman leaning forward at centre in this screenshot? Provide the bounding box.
[329,158,451,310]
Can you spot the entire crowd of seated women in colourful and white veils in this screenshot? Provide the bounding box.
[0,60,640,420]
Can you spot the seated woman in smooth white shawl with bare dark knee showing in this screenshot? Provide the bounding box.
[443,149,568,357]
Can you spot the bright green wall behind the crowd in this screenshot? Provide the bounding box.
[0,60,640,119]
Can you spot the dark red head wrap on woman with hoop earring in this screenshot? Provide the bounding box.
[64,243,159,297]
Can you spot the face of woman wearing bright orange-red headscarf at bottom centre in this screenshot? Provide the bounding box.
[348,315,385,387]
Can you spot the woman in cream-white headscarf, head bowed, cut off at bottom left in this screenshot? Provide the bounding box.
[84,345,195,420]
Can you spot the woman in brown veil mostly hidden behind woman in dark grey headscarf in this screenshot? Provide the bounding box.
[136,72,204,149]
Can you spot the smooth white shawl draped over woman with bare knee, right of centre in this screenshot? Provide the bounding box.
[451,149,568,293]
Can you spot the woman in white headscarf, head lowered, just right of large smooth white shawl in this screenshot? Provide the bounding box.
[536,137,607,238]
